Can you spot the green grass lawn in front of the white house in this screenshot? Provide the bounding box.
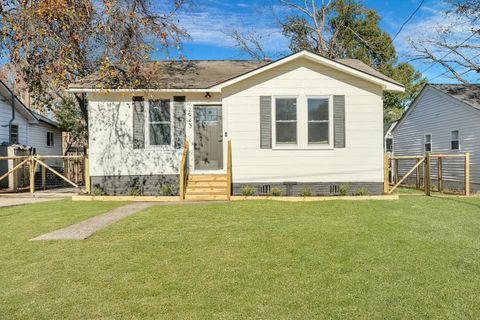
[0,196,480,319]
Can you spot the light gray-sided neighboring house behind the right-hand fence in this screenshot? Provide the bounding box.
[393,84,480,191]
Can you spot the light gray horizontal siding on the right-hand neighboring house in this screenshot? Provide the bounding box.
[393,87,480,183]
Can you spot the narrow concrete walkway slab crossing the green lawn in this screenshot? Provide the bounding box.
[30,202,157,241]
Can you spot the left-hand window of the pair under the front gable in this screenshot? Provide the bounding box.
[275,98,297,145]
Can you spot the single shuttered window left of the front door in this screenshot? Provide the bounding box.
[148,99,172,146]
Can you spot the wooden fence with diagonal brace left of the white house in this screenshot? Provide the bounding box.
[0,155,90,193]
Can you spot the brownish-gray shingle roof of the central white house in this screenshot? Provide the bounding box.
[70,53,402,89]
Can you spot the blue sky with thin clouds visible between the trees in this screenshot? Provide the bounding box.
[171,0,479,83]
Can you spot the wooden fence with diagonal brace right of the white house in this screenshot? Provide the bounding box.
[383,152,470,196]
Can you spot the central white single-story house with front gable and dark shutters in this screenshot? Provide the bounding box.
[70,51,404,199]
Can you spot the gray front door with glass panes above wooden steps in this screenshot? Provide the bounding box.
[194,105,223,170]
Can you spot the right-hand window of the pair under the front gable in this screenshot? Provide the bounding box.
[307,98,330,145]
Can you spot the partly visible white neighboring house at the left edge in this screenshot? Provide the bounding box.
[0,81,63,187]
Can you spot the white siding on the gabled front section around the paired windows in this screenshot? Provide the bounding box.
[223,57,383,183]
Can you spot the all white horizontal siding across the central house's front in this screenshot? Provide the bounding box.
[89,60,383,183]
